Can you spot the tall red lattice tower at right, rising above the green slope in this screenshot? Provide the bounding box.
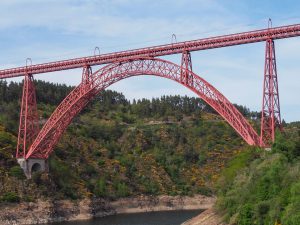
[260,39,282,147]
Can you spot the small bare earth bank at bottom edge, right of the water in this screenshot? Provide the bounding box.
[181,208,226,225]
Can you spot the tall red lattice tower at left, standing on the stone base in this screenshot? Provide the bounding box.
[16,74,39,158]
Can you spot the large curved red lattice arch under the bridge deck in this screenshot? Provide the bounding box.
[26,58,260,159]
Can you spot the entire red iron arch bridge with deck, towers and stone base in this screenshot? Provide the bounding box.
[0,21,300,177]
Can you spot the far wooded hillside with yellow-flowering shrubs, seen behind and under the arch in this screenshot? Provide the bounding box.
[0,81,253,201]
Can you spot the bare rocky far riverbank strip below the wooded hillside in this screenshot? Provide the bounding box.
[0,195,215,225]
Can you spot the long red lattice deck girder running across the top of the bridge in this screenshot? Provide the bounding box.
[0,24,300,79]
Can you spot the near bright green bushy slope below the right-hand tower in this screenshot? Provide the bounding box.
[217,125,300,225]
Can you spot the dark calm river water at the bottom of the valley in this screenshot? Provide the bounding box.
[51,210,201,225]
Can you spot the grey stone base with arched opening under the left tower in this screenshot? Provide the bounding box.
[17,158,49,179]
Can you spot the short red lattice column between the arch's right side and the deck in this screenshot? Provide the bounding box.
[180,51,193,86]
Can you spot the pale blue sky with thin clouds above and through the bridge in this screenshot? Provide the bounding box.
[0,0,300,122]
